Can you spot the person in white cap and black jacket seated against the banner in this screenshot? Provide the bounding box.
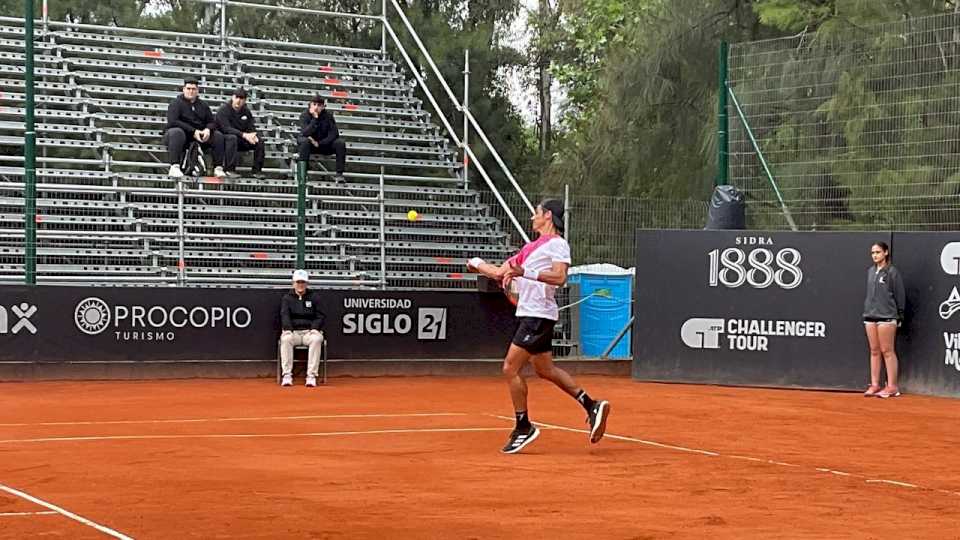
[280,270,326,386]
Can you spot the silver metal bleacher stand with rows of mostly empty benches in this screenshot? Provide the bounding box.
[0,17,509,288]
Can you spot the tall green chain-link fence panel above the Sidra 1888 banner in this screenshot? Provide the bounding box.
[728,13,960,230]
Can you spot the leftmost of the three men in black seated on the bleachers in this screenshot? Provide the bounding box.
[163,79,233,178]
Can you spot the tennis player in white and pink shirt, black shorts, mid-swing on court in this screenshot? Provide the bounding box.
[467,199,610,454]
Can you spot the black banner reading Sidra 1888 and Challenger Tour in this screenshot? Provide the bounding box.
[633,230,888,389]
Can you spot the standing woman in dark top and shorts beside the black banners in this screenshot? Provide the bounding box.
[863,242,905,398]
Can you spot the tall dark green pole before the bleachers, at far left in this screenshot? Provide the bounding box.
[23,0,37,285]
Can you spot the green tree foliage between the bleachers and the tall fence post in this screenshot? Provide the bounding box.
[545,0,755,198]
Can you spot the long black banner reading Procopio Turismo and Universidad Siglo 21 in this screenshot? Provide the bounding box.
[0,286,515,362]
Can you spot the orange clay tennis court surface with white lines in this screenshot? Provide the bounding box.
[0,377,960,539]
